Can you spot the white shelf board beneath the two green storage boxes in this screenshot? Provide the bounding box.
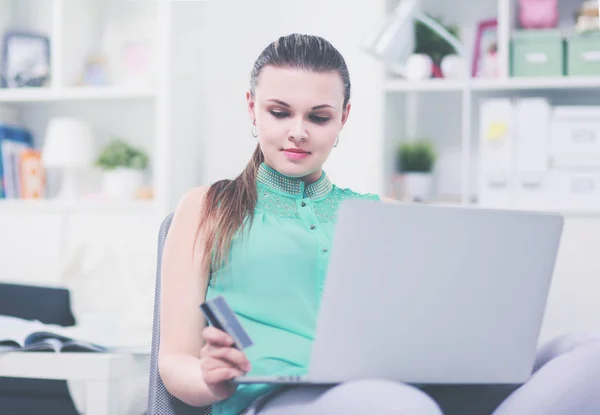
[385,77,600,92]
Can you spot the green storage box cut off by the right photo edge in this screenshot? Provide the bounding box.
[567,33,600,76]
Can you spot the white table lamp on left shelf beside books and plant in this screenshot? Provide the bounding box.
[42,117,95,200]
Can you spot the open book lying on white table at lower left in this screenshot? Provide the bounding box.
[0,316,134,353]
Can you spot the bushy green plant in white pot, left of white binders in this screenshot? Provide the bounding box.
[396,140,437,201]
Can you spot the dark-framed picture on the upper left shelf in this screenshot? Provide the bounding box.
[0,31,51,88]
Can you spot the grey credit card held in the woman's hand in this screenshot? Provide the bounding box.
[200,296,254,350]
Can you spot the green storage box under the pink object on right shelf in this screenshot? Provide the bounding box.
[510,29,566,77]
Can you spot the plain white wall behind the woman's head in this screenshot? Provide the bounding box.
[195,0,384,197]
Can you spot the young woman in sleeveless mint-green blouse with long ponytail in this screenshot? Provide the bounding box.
[159,34,600,415]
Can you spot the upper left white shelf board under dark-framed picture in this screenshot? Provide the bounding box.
[0,86,155,102]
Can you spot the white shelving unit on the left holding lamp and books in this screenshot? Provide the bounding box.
[0,0,190,215]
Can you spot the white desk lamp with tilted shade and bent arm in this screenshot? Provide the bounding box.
[363,0,468,78]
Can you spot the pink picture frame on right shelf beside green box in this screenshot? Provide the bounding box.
[471,18,498,78]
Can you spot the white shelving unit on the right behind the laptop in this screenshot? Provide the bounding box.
[384,0,600,215]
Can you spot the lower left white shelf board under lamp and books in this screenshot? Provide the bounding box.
[0,199,155,215]
